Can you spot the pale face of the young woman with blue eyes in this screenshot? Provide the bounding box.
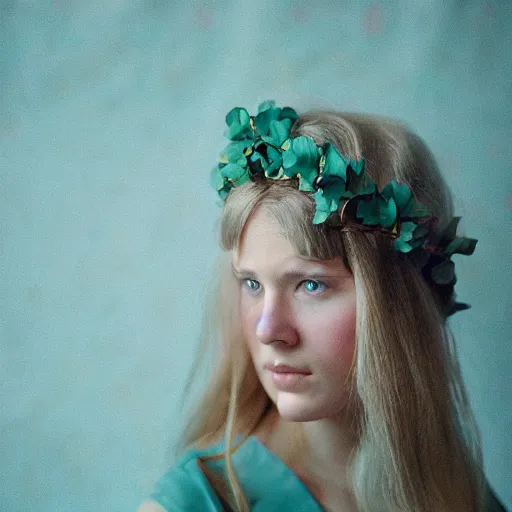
[233,208,356,421]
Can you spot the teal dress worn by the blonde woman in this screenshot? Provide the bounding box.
[151,436,506,512]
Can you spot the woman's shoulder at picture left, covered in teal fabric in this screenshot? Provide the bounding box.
[147,444,229,512]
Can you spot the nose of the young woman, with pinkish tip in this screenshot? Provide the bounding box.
[256,296,299,346]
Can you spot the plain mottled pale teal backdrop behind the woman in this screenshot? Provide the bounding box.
[0,0,512,512]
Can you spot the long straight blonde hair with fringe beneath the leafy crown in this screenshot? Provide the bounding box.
[176,111,484,512]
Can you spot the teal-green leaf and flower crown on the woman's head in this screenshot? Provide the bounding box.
[214,101,477,317]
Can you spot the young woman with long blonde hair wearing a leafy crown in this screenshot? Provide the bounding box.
[139,102,504,512]
